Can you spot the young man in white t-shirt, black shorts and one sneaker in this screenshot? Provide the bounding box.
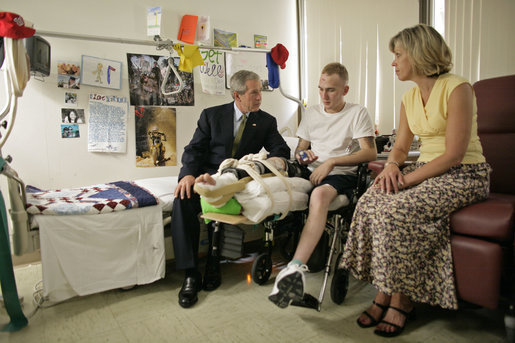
[268,63,377,308]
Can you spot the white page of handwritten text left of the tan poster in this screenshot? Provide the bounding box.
[88,93,128,153]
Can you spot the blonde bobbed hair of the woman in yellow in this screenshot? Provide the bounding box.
[389,24,452,76]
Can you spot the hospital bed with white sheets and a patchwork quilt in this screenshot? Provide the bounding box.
[7,173,177,302]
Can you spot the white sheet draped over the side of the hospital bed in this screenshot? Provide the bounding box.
[34,176,177,301]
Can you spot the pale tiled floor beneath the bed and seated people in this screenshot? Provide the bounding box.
[0,258,505,343]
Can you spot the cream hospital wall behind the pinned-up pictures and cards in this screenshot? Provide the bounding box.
[0,0,299,191]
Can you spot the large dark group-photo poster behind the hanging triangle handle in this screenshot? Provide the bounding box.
[127,54,195,106]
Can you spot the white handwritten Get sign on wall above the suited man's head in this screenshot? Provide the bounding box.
[199,49,225,95]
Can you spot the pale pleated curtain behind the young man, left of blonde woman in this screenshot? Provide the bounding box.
[300,0,419,134]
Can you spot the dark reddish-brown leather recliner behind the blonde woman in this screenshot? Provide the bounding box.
[450,75,515,309]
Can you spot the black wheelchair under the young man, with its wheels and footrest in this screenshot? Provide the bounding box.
[251,163,371,311]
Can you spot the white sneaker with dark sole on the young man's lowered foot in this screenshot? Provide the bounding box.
[268,262,309,308]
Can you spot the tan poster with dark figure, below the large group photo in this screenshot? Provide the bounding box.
[134,106,177,167]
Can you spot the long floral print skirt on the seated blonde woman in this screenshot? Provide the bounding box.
[340,162,490,309]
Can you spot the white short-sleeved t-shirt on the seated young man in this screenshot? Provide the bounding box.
[297,102,374,175]
